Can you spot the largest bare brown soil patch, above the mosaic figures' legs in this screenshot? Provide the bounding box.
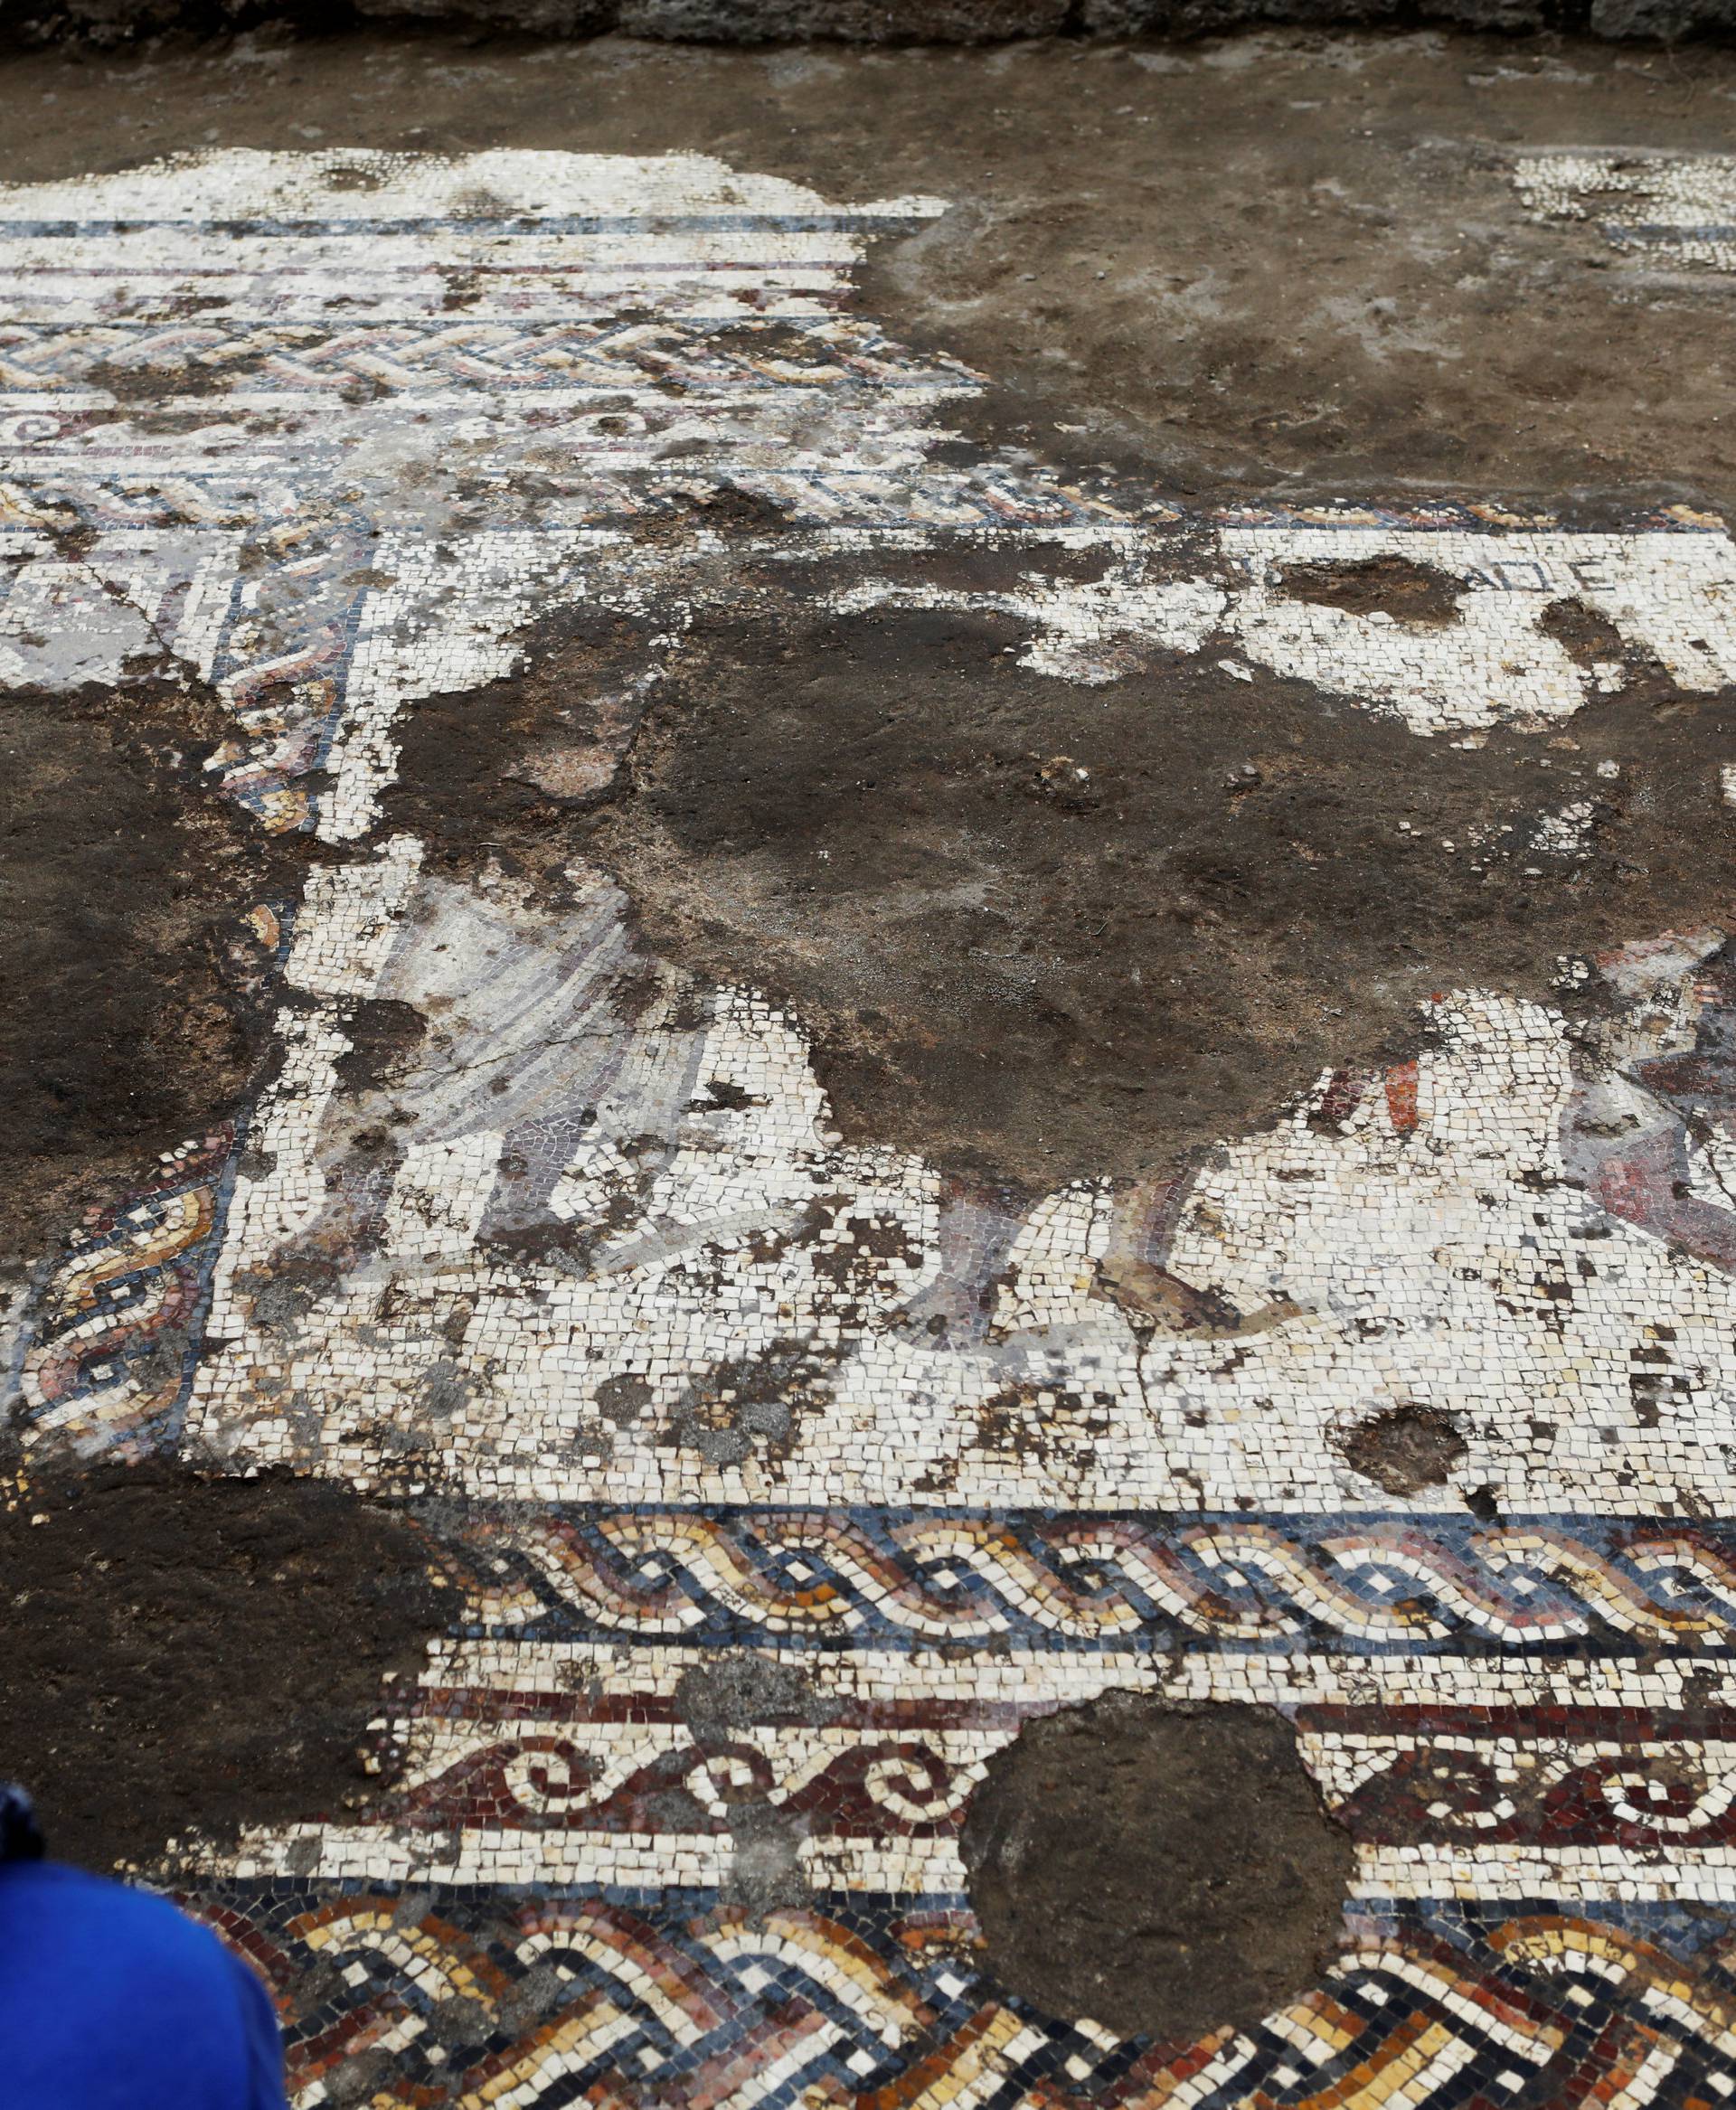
[565,589,1736,1188]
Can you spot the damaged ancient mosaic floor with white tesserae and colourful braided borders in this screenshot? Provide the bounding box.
[0,150,1736,2110]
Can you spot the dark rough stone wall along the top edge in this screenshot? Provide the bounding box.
[0,0,1736,44]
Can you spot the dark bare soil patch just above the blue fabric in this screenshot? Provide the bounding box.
[0,1465,451,1870]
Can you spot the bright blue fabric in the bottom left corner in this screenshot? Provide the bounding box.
[0,1861,283,2110]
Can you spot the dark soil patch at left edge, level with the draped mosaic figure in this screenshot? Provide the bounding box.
[0,680,306,1266]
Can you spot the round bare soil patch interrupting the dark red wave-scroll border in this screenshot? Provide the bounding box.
[962,1692,1354,2042]
